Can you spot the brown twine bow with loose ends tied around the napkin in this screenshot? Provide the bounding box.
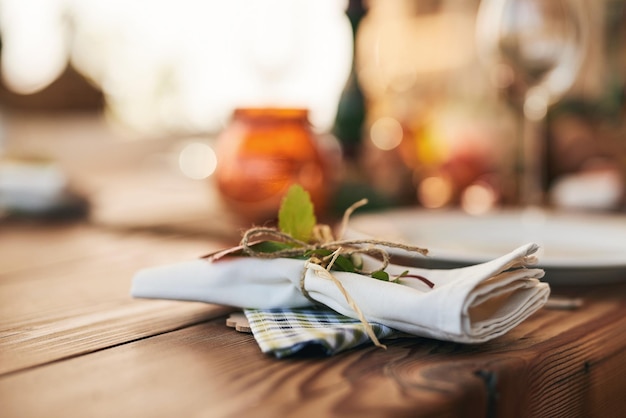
[240,199,428,348]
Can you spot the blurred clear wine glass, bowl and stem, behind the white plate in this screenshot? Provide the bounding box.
[476,0,587,207]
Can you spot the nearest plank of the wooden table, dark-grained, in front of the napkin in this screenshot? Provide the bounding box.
[0,285,626,417]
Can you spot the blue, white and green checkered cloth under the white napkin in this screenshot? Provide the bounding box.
[244,308,396,358]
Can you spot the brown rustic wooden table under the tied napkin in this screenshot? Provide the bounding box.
[0,114,626,418]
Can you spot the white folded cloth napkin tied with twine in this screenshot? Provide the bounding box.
[131,244,550,343]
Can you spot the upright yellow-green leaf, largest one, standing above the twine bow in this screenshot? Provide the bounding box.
[278,184,317,242]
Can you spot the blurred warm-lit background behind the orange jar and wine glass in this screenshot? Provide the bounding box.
[0,0,626,227]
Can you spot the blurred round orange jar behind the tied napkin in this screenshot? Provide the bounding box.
[215,108,332,222]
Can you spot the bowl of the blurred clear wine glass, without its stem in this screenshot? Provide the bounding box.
[477,0,586,108]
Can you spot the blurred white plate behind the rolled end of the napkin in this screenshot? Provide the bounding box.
[345,209,626,284]
